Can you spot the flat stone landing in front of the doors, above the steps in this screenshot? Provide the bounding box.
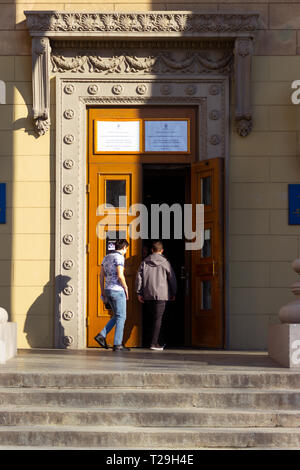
[0,348,292,375]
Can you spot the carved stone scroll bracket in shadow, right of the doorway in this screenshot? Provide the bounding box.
[234,37,253,137]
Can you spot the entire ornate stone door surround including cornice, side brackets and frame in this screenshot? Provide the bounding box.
[26,11,258,349]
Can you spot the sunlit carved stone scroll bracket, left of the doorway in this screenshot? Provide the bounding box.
[32,37,51,135]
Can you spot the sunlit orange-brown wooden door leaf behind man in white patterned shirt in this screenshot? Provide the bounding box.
[87,163,141,347]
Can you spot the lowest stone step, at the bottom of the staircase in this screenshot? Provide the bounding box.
[0,426,300,450]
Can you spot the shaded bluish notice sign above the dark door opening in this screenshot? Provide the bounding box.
[145,121,189,152]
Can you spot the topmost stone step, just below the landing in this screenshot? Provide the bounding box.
[0,369,300,390]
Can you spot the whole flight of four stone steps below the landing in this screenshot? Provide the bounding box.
[0,370,300,450]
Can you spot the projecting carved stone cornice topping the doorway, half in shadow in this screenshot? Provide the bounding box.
[24,11,259,39]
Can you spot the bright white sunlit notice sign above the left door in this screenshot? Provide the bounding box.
[97,121,140,152]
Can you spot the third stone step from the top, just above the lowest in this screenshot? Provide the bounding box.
[0,405,300,428]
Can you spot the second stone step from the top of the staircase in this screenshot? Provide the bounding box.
[0,388,300,410]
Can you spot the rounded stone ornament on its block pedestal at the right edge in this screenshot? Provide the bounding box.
[268,258,300,368]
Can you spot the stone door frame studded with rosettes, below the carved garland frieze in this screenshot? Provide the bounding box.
[55,75,229,349]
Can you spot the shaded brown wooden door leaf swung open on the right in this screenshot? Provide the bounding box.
[191,158,224,348]
